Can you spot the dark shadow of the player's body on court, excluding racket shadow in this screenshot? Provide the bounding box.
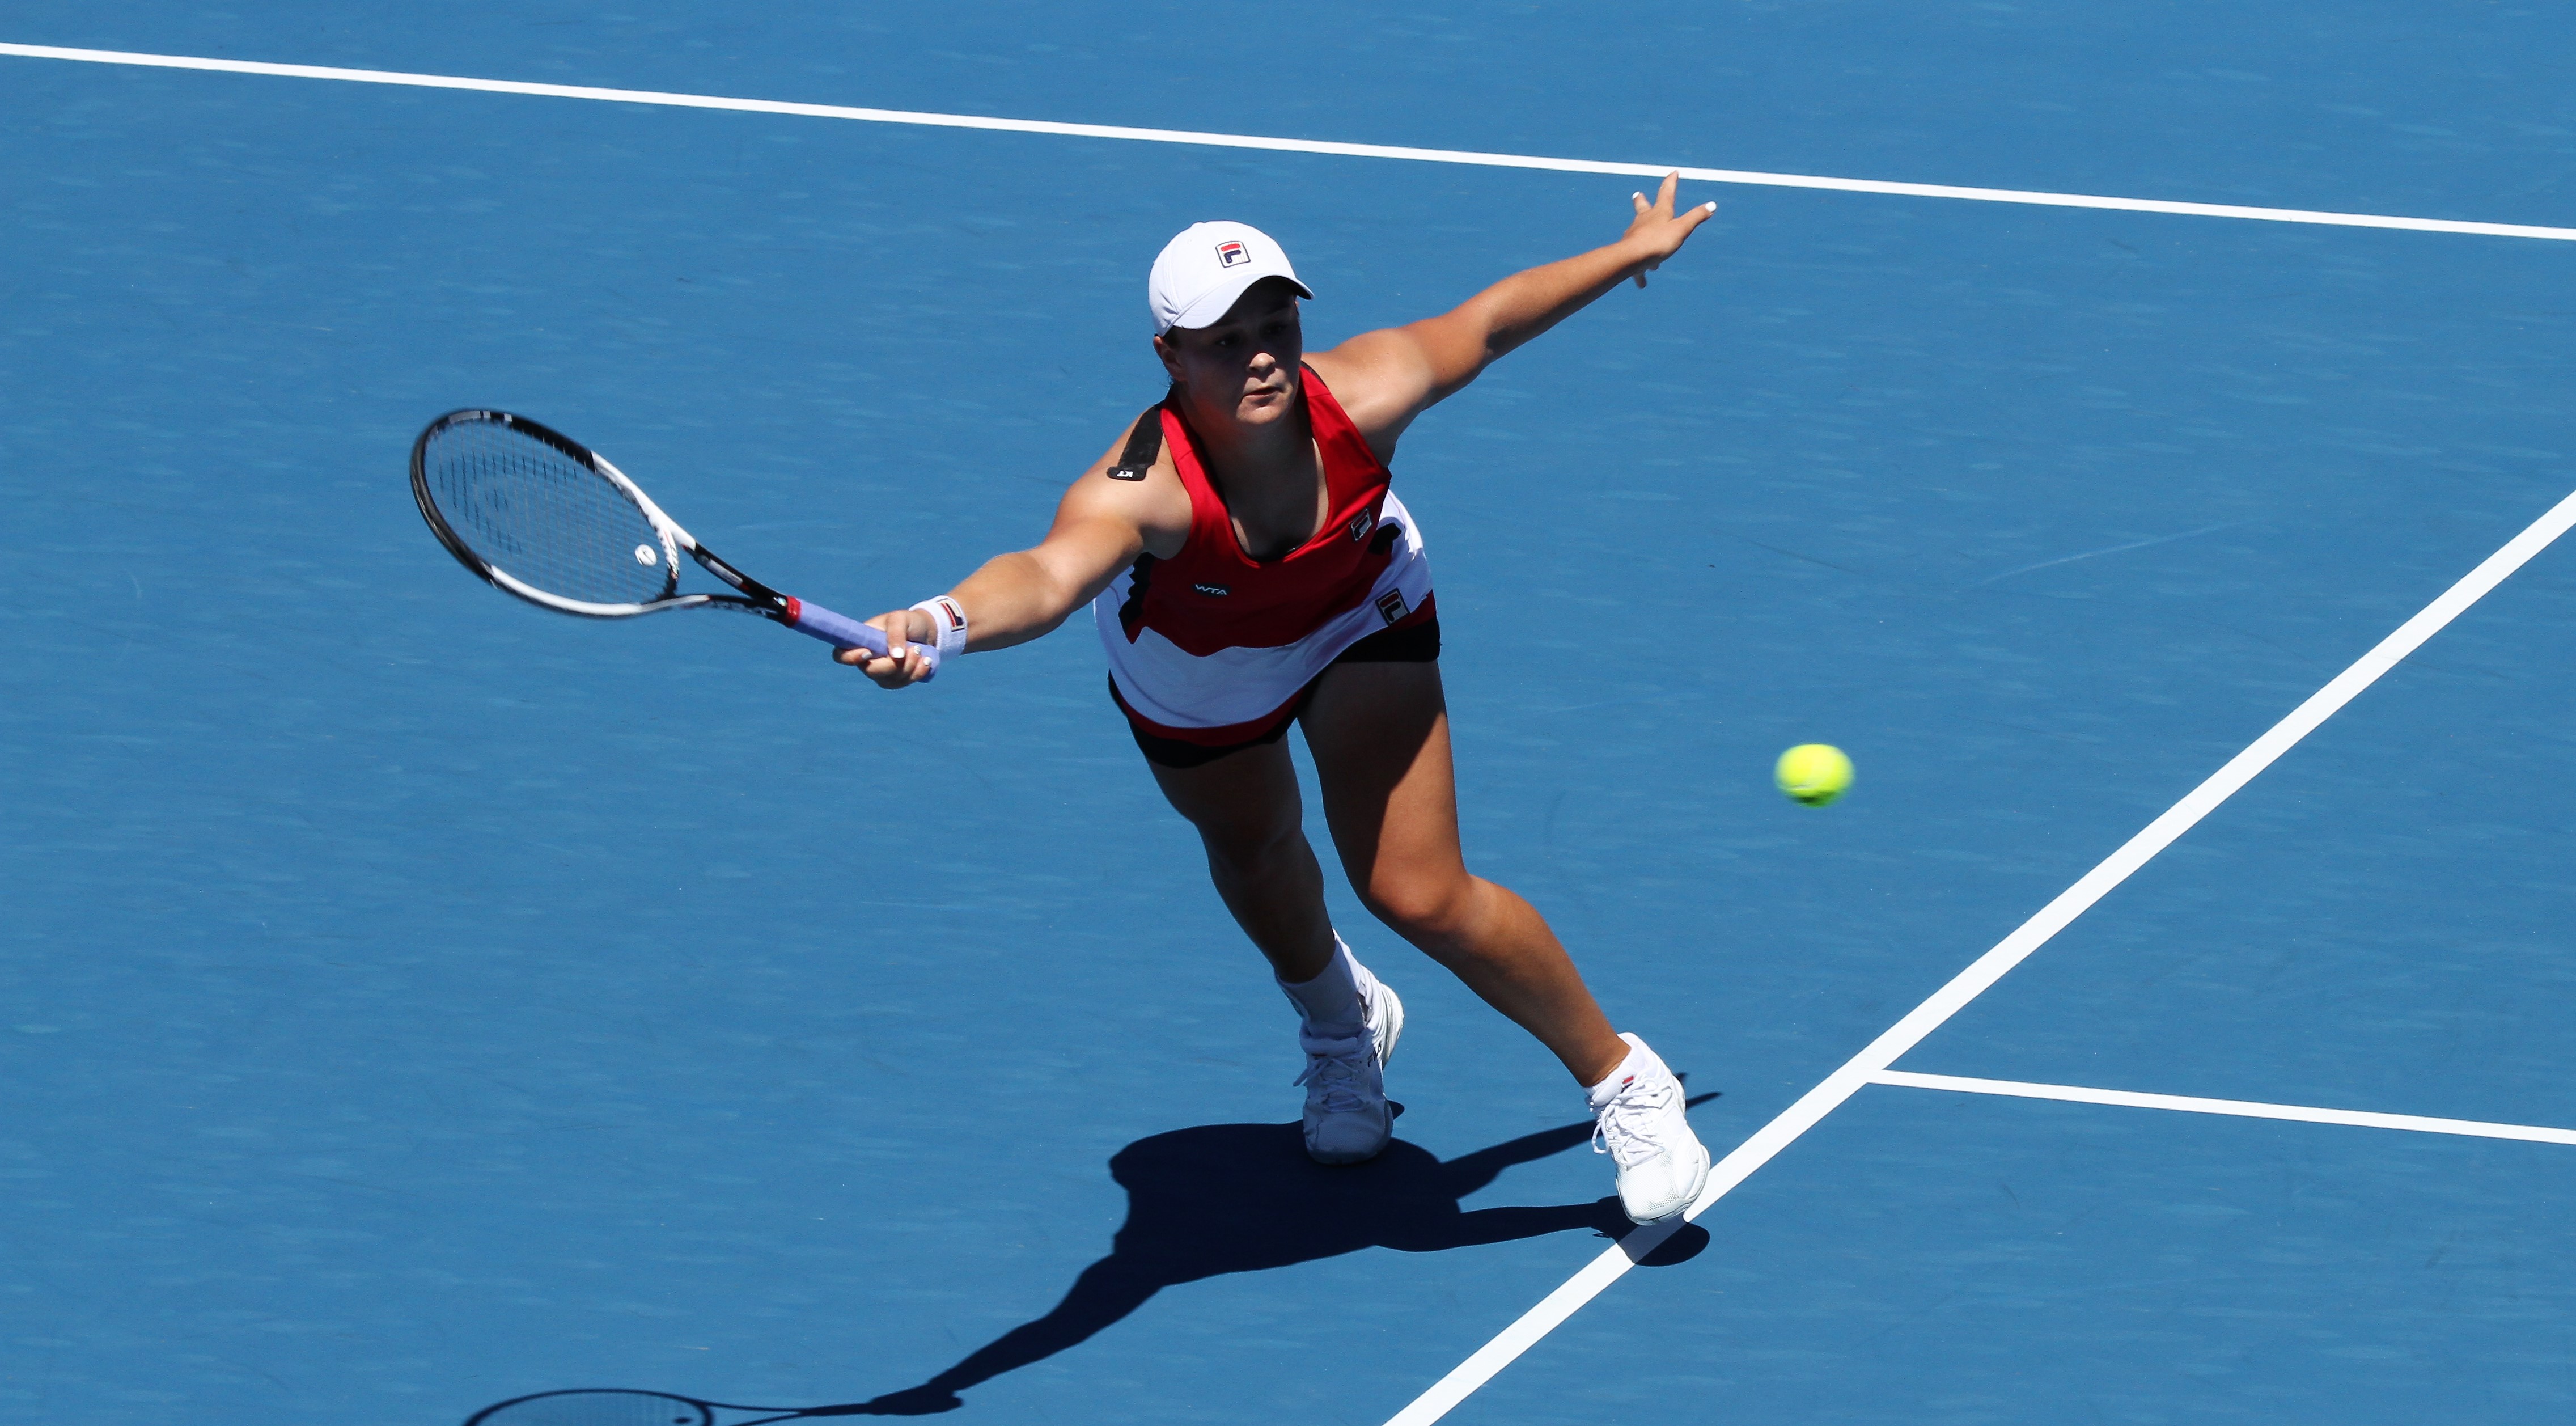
[850,1093,1715,1416]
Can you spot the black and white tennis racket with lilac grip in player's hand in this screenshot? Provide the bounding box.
[412,410,940,675]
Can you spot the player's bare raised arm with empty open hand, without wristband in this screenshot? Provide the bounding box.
[1316,173,1718,456]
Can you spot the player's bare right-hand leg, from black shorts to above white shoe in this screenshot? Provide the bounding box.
[1301,663,1628,1086]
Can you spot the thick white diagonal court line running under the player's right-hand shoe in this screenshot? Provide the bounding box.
[1386,485,2576,1426]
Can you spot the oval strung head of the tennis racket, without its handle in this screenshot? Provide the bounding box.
[422,420,675,603]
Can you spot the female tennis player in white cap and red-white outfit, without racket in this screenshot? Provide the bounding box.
[837,175,1715,1222]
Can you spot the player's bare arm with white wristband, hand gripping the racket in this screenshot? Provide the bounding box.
[832,420,1190,688]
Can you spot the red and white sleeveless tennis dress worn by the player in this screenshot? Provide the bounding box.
[1092,366,1435,748]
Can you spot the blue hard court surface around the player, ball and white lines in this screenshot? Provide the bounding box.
[0,0,2576,1426]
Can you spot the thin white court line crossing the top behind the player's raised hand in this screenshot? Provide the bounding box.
[0,44,2576,243]
